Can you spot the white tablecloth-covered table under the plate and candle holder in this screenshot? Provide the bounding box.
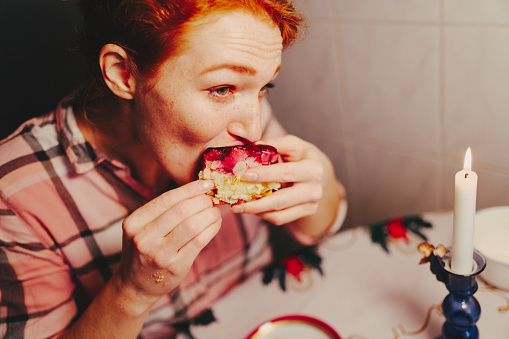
[180,212,509,339]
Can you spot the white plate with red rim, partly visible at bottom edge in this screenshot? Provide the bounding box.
[246,315,341,339]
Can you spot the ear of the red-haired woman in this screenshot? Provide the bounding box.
[99,44,136,100]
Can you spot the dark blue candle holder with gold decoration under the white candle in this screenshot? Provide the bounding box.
[429,248,486,339]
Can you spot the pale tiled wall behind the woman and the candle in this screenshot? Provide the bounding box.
[269,0,509,230]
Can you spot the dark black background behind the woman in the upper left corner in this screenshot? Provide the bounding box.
[0,0,82,139]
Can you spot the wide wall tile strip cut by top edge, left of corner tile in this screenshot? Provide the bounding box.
[332,0,439,22]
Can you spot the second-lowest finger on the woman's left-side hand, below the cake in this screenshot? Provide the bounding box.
[164,207,221,255]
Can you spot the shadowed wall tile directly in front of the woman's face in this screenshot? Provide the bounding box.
[268,24,343,139]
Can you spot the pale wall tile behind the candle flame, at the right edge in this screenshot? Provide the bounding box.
[444,27,509,168]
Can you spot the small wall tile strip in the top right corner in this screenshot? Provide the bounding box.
[444,0,509,25]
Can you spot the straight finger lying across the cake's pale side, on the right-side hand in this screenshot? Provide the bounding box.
[242,159,323,183]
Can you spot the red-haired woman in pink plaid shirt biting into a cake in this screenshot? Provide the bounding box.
[0,0,345,338]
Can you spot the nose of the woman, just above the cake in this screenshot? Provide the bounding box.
[228,99,262,141]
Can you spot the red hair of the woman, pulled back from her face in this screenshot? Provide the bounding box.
[80,0,303,115]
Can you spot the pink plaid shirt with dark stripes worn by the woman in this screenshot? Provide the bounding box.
[0,100,282,338]
